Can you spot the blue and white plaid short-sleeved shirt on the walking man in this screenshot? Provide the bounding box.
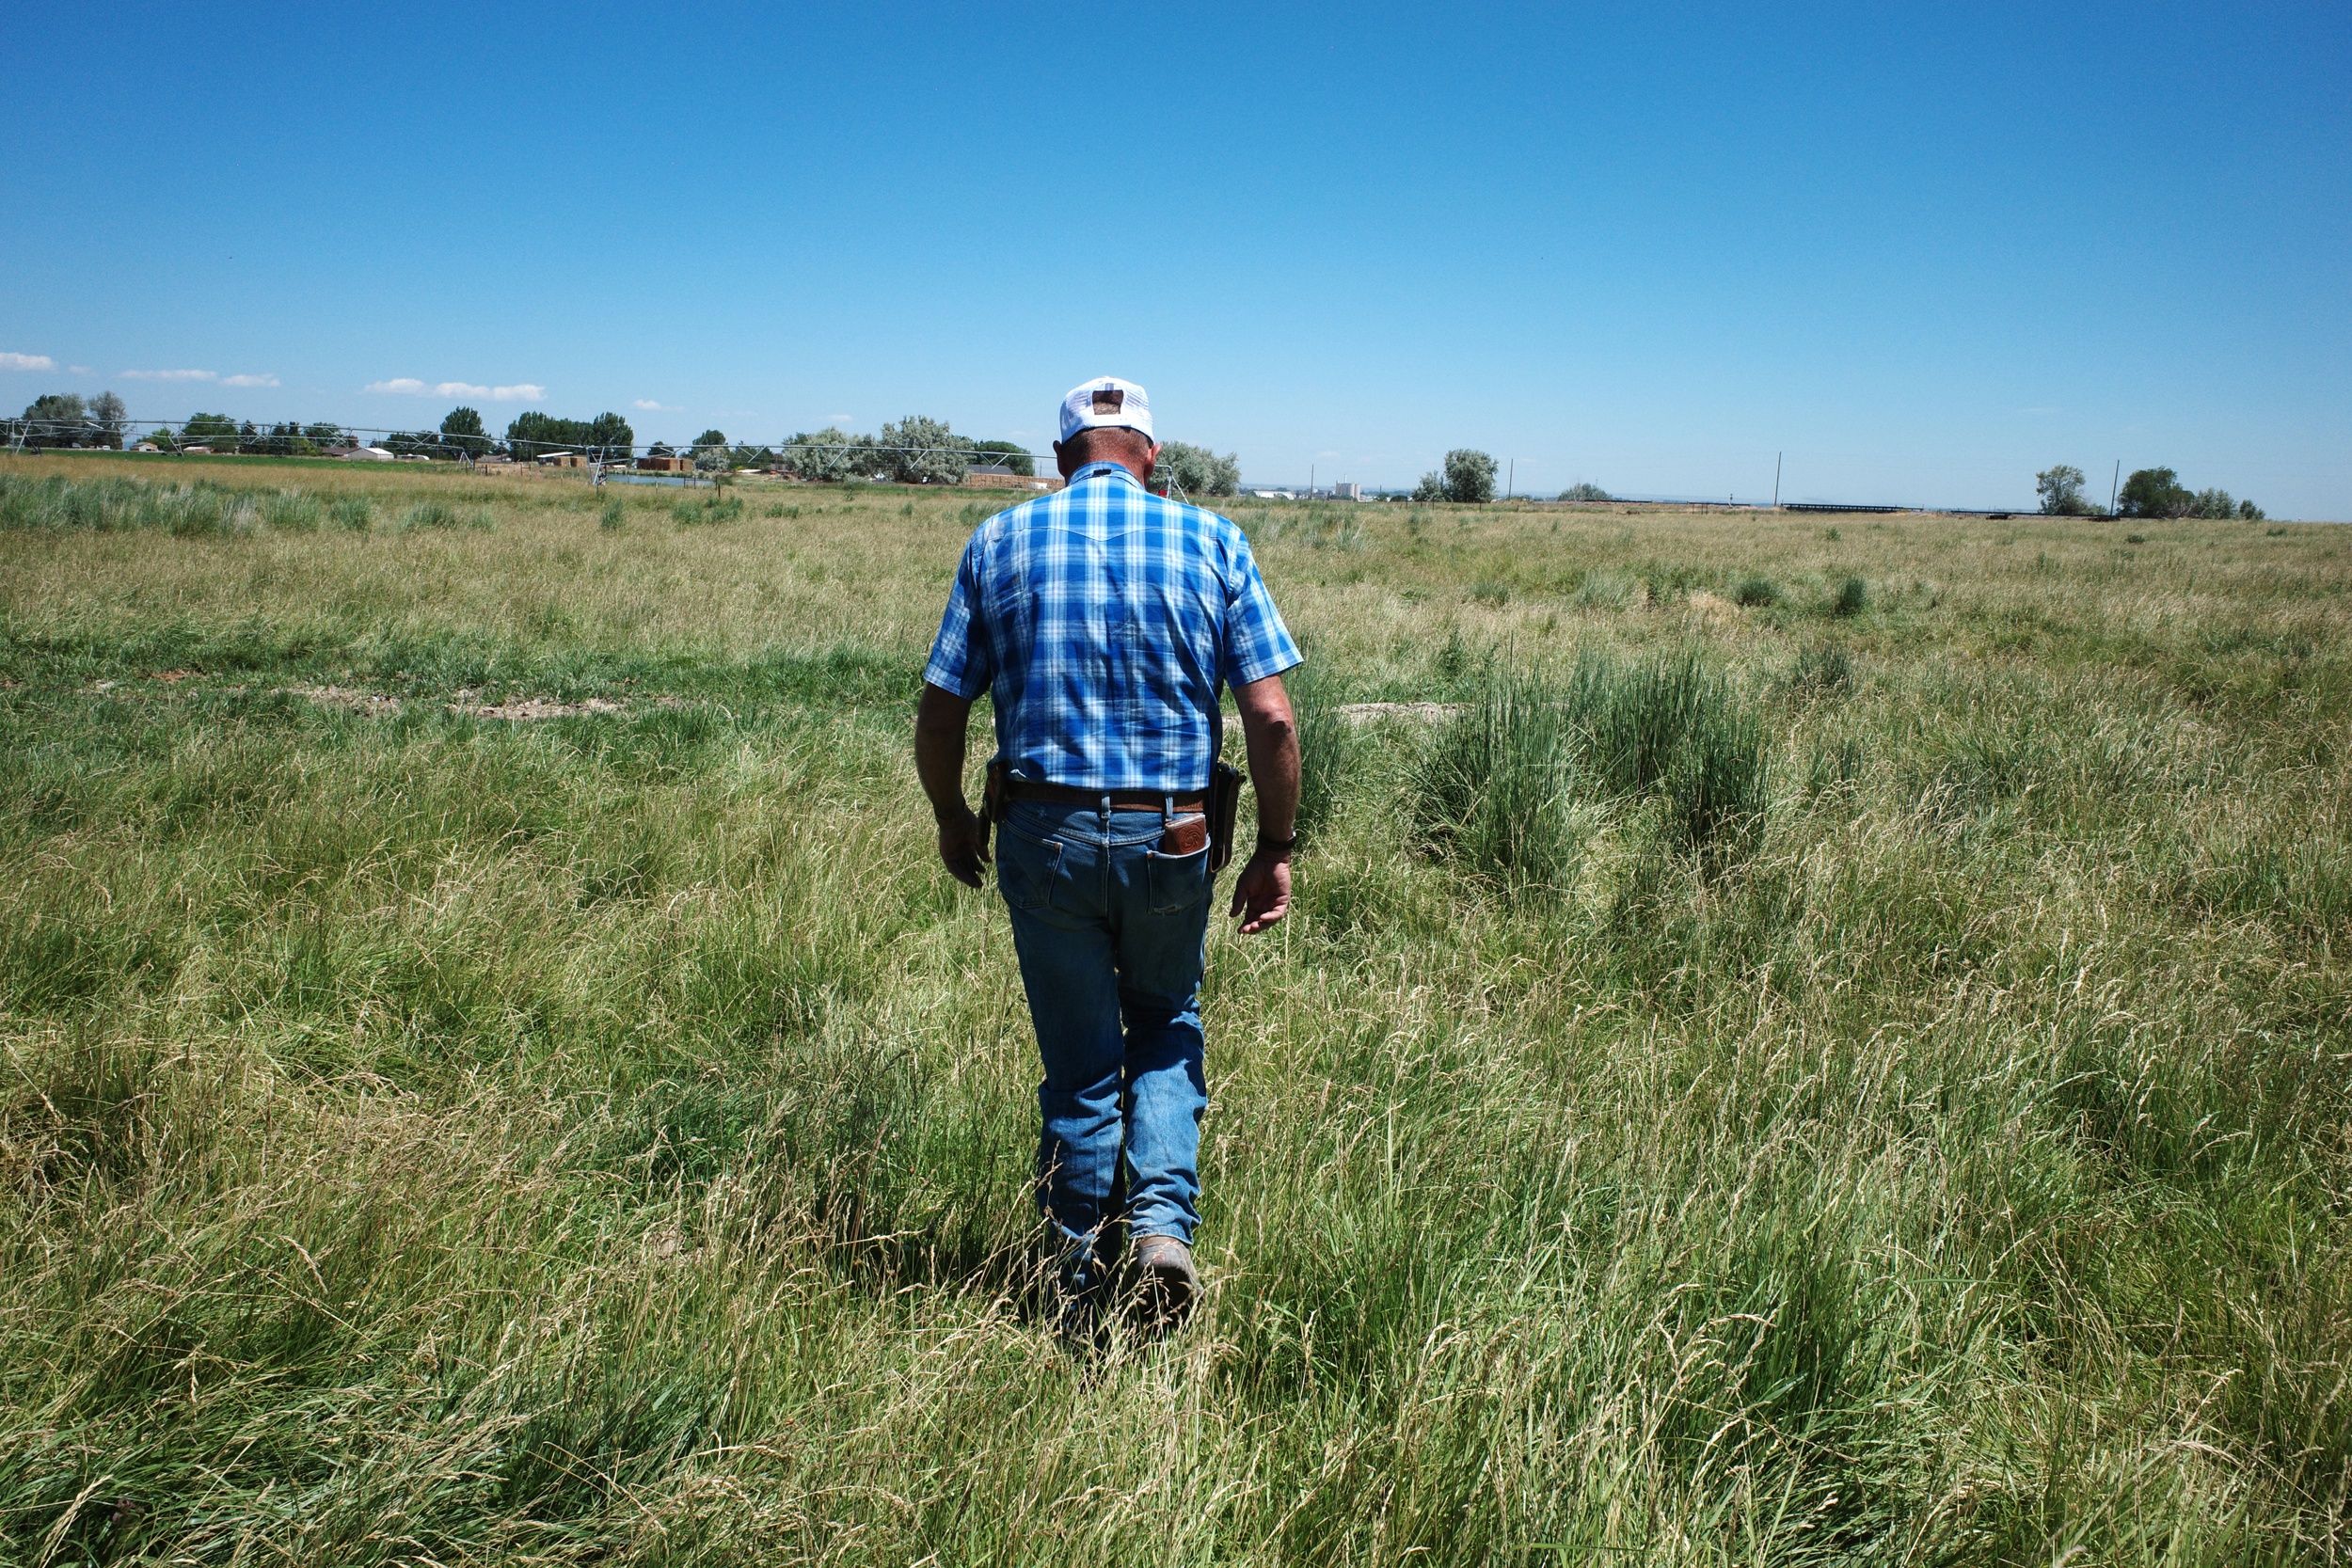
[922,463,1301,792]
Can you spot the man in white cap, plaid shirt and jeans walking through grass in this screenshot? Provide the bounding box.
[915,376,1298,1340]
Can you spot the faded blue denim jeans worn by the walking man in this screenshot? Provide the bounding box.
[997,801,1214,1291]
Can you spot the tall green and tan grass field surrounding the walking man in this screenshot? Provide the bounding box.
[0,446,2352,1566]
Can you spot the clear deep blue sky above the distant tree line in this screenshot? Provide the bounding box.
[0,0,2352,517]
